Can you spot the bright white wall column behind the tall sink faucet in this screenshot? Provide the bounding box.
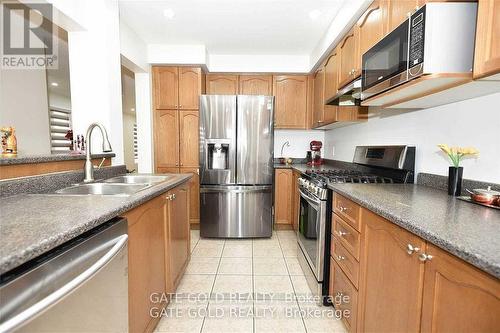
[66,0,123,164]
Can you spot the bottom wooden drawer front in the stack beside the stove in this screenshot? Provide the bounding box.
[330,259,358,332]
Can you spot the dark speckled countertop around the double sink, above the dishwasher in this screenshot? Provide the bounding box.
[0,174,192,274]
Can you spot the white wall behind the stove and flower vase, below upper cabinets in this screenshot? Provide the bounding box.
[325,93,500,183]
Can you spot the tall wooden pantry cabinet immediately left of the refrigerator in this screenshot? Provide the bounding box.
[153,66,205,223]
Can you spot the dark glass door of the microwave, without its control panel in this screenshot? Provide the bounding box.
[361,20,409,99]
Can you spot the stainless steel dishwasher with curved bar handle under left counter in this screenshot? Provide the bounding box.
[0,218,128,333]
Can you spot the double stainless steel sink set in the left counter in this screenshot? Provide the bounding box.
[55,175,174,196]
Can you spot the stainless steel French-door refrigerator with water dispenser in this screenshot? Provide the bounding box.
[200,95,274,238]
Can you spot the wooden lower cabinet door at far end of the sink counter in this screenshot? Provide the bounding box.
[165,184,191,292]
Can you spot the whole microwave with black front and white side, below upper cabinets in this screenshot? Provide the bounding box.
[361,2,477,99]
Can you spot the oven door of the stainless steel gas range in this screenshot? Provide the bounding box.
[297,190,326,282]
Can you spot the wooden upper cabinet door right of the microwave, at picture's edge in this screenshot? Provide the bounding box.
[474,0,500,80]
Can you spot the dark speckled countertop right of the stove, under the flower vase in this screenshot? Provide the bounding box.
[329,184,500,278]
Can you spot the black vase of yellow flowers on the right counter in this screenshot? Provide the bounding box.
[438,144,479,196]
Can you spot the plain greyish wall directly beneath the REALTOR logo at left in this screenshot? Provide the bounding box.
[0,69,50,155]
